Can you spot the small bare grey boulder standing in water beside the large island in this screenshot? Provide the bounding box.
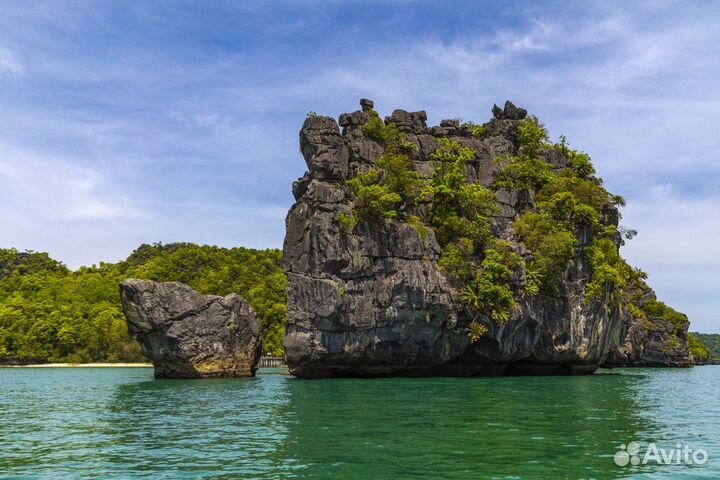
[120,280,262,378]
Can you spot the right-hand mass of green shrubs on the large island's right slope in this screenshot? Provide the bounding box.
[494,117,640,302]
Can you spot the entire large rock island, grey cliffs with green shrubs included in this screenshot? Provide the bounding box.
[284,100,691,378]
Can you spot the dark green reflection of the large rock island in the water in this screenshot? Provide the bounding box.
[282,374,655,478]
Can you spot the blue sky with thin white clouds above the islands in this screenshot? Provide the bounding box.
[0,0,720,332]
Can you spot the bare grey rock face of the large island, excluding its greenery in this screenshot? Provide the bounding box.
[284,100,687,378]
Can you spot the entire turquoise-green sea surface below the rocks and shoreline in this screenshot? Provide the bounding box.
[0,366,720,479]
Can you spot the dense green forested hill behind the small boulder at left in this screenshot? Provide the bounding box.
[0,243,287,362]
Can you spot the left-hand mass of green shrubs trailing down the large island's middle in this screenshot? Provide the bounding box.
[346,117,524,341]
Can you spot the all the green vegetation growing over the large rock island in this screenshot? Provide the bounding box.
[339,111,687,348]
